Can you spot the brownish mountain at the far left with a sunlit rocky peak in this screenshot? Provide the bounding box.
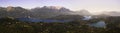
[0,6,30,18]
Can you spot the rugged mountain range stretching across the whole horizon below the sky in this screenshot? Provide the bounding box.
[0,6,120,19]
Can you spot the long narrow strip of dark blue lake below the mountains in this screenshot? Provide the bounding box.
[17,18,71,22]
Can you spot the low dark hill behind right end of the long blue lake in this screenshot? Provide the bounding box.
[48,15,84,20]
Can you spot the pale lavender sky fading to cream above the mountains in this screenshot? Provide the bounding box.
[0,0,120,13]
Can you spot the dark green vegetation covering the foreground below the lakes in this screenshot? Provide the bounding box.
[0,17,120,33]
